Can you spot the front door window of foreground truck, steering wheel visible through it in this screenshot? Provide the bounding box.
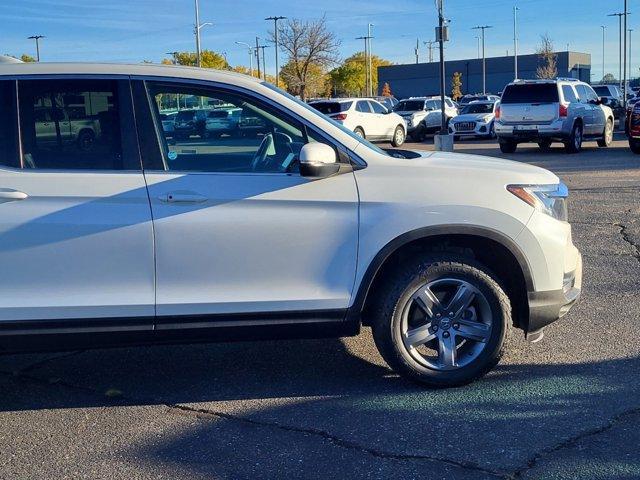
[145,83,335,173]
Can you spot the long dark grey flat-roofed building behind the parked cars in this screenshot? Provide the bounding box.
[378,52,591,98]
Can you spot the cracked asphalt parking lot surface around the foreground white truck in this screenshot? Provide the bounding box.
[0,133,640,480]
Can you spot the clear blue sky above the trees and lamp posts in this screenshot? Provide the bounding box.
[0,0,640,78]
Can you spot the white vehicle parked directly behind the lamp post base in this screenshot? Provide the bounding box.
[393,96,458,142]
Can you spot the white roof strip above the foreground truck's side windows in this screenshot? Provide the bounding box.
[0,62,261,85]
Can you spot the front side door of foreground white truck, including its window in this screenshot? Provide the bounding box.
[134,81,358,322]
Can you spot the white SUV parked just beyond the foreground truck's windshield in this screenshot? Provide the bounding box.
[309,98,407,147]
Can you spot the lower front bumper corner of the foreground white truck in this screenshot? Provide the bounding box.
[525,250,582,341]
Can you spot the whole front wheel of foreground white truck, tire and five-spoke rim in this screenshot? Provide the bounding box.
[372,254,511,387]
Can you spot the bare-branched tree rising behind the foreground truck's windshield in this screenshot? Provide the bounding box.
[271,17,340,100]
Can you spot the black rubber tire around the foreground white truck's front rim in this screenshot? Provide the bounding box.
[372,253,512,388]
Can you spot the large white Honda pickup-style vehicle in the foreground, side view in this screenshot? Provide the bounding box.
[0,63,582,386]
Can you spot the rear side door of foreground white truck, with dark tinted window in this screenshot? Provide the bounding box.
[0,78,155,324]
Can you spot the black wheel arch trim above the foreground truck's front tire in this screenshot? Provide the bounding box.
[351,225,534,328]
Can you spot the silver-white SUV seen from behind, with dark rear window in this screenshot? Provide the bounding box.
[495,78,614,153]
